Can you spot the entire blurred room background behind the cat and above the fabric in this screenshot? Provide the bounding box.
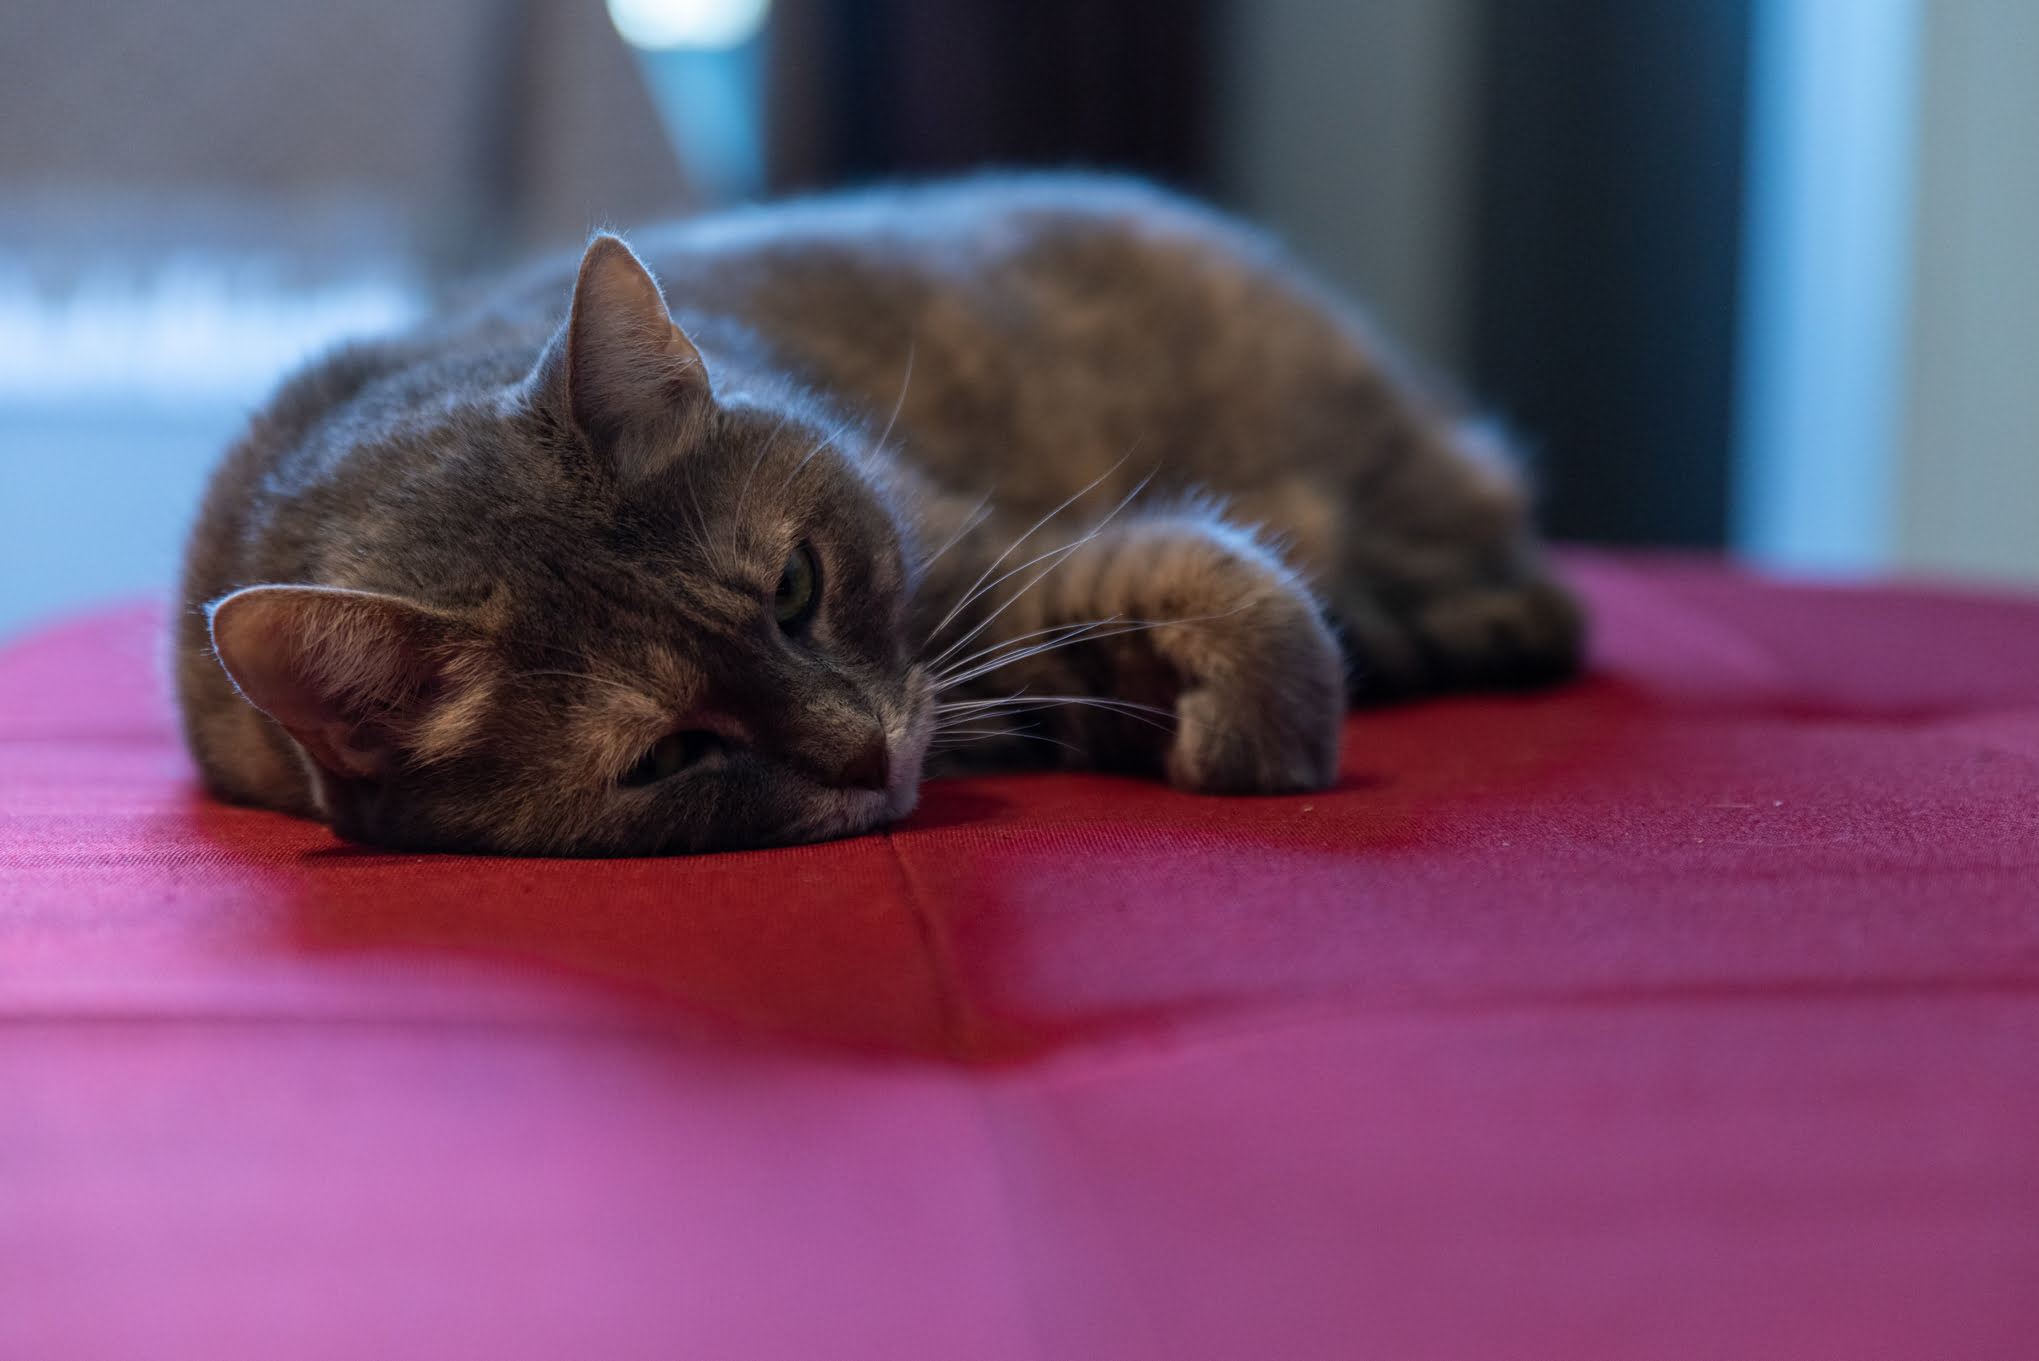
[0,0,2039,637]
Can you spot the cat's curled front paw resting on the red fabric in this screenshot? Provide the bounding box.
[1125,531,1346,794]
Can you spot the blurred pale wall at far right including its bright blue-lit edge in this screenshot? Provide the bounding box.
[1735,0,2039,582]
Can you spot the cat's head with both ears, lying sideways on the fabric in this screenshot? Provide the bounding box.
[198,237,932,855]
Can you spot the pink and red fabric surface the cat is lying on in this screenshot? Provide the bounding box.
[0,553,2039,1361]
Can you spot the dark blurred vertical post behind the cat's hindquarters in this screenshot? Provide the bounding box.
[1472,0,1754,547]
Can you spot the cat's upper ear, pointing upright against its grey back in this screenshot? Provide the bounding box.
[528,235,712,484]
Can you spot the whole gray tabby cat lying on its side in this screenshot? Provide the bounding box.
[177,178,1580,855]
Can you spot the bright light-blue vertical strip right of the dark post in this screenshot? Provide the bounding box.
[1735,0,1925,573]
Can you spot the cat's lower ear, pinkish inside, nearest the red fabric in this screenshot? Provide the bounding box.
[210,586,487,779]
